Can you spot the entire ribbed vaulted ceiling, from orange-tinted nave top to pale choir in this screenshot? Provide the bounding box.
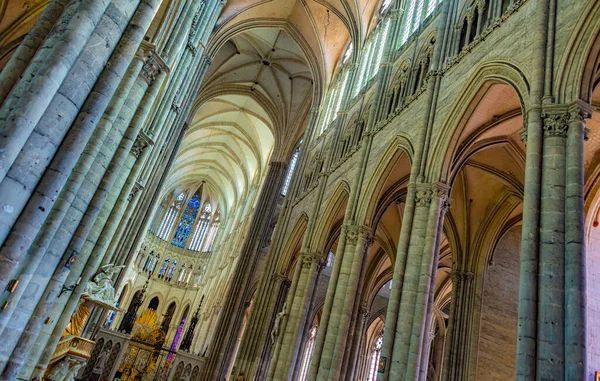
[169,0,390,208]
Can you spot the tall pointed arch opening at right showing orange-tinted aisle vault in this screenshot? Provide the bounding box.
[440,82,525,380]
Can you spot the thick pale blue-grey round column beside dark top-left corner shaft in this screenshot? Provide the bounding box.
[0,0,111,184]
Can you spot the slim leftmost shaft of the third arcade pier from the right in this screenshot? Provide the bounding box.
[307,227,347,381]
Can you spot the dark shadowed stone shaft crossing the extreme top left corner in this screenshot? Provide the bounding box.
[0,0,71,105]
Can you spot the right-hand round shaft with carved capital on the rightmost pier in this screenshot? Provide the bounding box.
[565,105,591,380]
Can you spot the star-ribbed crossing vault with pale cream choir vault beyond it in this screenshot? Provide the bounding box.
[168,28,313,209]
